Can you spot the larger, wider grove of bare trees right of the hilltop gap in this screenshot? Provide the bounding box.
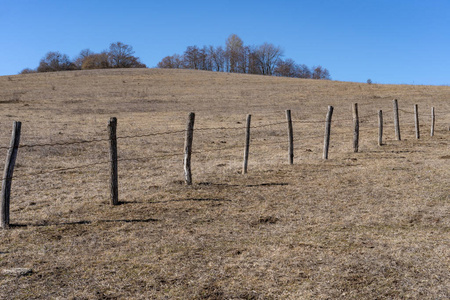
[158,34,331,79]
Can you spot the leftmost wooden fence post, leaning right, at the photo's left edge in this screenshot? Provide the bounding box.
[0,122,22,229]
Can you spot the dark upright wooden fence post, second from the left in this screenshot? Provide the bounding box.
[108,117,119,205]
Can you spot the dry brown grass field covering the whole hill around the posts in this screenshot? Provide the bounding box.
[0,69,450,299]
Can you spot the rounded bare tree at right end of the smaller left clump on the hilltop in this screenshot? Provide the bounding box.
[108,42,146,68]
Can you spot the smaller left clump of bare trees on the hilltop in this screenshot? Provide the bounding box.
[20,42,147,74]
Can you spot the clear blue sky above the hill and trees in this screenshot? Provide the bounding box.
[0,0,450,85]
